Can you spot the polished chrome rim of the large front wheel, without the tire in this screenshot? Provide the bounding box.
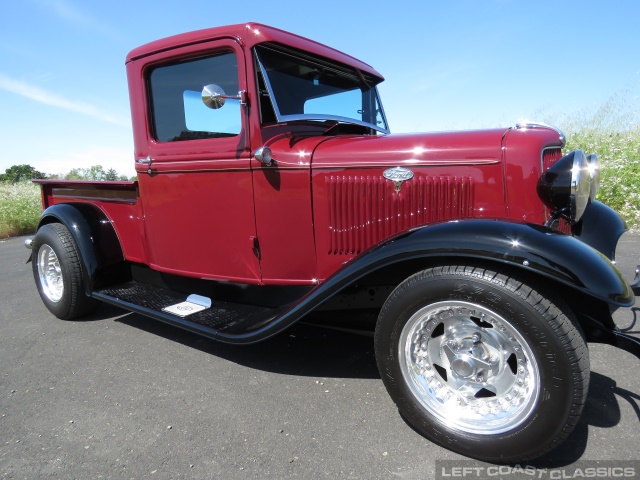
[398,300,540,435]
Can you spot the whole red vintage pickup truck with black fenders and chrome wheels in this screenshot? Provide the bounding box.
[26,23,640,462]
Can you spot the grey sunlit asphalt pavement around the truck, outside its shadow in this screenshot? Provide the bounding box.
[0,233,640,480]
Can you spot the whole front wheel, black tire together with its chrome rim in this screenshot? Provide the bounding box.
[375,266,589,463]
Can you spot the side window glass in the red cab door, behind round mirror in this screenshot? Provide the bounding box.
[149,52,241,142]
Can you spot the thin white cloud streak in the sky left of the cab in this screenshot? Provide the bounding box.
[0,74,131,128]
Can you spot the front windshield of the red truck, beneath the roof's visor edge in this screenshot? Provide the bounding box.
[255,44,389,133]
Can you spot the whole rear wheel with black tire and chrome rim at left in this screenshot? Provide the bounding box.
[32,223,97,320]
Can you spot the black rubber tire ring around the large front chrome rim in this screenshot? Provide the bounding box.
[376,275,575,461]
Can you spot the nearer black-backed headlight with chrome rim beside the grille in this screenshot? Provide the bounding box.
[537,150,599,223]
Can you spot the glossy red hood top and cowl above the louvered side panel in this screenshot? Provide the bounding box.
[270,129,508,168]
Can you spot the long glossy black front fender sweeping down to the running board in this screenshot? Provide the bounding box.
[214,219,634,343]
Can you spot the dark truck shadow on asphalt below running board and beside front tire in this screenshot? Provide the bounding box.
[96,306,640,468]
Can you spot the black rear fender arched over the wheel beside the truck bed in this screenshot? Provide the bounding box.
[38,203,124,295]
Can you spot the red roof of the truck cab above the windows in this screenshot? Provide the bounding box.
[127,22,384,79]
